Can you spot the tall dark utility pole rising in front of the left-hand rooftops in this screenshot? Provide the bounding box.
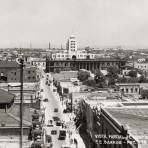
[20,59,24,148]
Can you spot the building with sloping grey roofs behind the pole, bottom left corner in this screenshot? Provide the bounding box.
[0,90,32,148]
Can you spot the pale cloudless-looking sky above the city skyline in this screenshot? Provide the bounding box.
[0,0,148,48]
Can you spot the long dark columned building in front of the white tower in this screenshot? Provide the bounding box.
[46,58,126,72]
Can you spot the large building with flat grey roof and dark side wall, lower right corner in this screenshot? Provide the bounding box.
[98,103,148,148]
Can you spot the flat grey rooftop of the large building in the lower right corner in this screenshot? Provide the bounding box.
[105,106,148,144]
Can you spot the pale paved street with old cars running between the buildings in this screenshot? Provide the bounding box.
[40,74,71,148]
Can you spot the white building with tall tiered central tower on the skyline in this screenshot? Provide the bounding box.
[52,35,95,60]
